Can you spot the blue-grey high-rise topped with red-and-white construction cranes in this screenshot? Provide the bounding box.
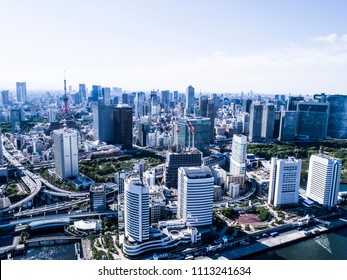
[174,118,211,153]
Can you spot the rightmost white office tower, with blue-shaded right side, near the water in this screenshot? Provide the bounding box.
[306,154,342,208]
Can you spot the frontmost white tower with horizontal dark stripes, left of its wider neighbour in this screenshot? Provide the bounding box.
[124,175,150,242]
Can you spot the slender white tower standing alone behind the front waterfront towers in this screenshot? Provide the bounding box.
[230,134,247,175]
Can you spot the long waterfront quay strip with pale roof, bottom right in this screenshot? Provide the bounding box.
[219,217,347,260]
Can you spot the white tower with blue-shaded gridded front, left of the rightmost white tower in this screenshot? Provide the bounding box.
[268,157,302,208]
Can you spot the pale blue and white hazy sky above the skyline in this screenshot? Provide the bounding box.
[0,0,347,94]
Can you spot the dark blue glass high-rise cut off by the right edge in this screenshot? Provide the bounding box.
[328,95,347,139]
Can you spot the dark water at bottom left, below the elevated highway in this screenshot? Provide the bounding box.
[13,244,76,260]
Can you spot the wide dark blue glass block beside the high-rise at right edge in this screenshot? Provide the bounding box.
[297,102,329,139]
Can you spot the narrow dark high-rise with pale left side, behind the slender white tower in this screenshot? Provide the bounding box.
[248,102,264,142]
